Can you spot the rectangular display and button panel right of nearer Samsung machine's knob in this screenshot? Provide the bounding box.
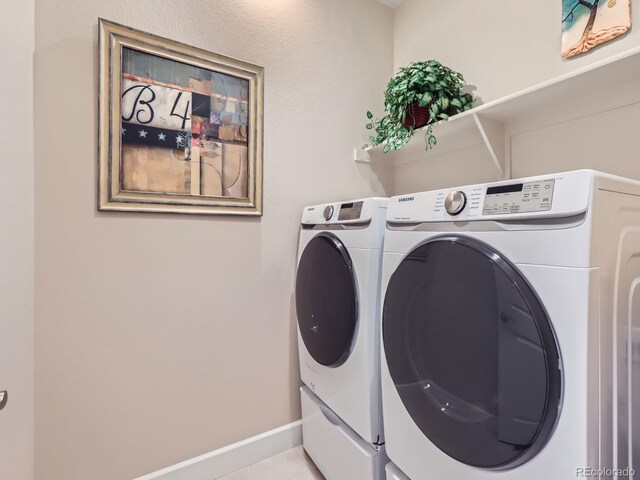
[482,178,555,215]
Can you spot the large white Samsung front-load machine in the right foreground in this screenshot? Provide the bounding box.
[381,170,640,480]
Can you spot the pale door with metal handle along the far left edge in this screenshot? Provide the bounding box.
[0,0,34,480]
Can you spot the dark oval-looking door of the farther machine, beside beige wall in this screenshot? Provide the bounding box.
[296,233,358,367]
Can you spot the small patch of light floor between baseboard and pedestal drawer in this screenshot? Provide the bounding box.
[218,447,325,480]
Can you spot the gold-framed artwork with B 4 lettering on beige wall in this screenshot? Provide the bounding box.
[98,19,264,215]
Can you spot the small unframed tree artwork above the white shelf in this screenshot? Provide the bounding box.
[562,0,631,58]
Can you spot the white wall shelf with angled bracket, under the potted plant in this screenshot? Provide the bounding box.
[356,43,640,178]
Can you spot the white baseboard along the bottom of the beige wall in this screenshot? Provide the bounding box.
[134,420,302,480]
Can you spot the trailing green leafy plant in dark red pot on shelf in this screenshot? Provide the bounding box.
[363,60,474,153]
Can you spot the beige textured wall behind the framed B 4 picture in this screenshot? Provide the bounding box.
[35,0,393,480]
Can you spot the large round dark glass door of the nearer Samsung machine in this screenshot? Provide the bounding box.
[383,237,562,469]
